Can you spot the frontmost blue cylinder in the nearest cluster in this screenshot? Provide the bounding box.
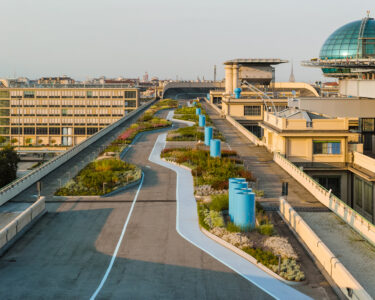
[234,191,255,230]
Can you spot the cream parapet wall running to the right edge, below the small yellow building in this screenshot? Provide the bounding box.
[273,153,375,246]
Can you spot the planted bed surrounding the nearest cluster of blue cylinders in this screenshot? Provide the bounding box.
[161,148,305,281]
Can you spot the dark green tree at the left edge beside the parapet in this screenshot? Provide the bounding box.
[0,145,20,188]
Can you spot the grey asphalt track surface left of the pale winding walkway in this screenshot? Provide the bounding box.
[0,111,271,299]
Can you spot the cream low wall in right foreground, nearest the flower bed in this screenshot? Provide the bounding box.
[280,198,372,299]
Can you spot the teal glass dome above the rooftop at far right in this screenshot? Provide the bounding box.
[319,19,375,59]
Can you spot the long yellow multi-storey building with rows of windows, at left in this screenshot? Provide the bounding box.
[0,87,139,148]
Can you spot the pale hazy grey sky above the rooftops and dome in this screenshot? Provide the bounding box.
[0,0,375,82]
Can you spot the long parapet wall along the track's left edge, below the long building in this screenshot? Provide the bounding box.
[0,100,155,206]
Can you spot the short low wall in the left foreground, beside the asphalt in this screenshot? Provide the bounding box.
[0,197,46,255]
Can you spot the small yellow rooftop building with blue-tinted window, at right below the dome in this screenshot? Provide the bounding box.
[260,108,361,163]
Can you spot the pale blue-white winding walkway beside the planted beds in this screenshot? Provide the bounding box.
[149,133,310,300]
